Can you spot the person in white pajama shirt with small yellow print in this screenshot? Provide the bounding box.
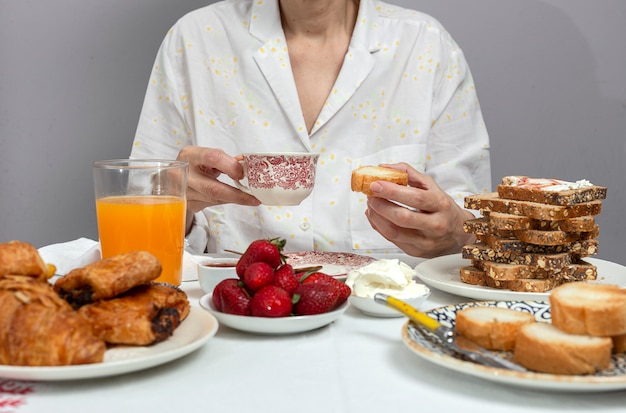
[131,0,491,257]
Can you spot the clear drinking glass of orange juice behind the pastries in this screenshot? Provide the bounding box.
[93,159,188,285]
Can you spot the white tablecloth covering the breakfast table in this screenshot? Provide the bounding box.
[0,246,626,413]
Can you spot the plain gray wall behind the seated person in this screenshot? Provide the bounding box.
[0,0,626,264]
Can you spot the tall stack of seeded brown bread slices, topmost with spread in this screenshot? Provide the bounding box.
[460,176,606,292]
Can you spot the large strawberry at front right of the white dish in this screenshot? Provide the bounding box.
[293,282,345,315]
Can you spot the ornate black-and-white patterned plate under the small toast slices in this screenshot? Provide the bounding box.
[402,301,626,392]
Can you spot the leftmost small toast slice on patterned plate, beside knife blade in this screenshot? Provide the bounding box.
[455,306,535,351]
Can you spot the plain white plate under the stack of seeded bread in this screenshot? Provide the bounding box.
[415,254,626,301]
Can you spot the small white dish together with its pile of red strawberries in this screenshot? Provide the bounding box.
[200,238,351,334]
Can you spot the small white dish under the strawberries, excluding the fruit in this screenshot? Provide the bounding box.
[200,294,350,334]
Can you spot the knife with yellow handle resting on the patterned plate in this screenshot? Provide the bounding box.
[374,293,528,372]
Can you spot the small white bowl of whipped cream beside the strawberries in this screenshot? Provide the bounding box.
[345,258,430,317]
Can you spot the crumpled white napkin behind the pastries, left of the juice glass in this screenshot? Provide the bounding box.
[39,238,100,275]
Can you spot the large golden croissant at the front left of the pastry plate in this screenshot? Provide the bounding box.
[0,275,106,366]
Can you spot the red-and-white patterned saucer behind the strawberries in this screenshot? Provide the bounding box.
[284,251,376,278]
